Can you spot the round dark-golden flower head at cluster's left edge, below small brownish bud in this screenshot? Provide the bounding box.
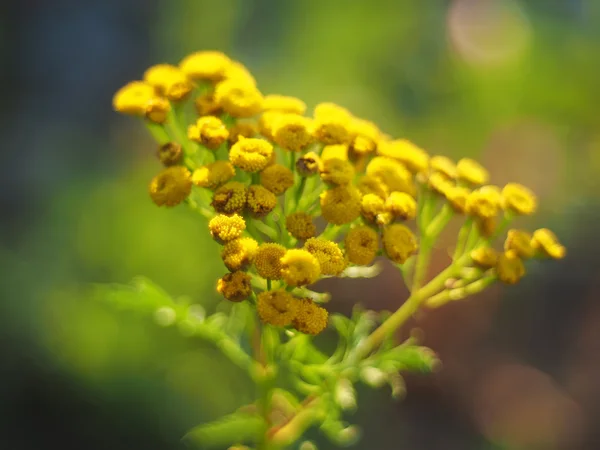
[148,166,192,206]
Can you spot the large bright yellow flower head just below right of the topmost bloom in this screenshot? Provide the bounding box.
[215,78,263,117]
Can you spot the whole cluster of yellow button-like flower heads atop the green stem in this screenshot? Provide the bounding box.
[113,51,565,334]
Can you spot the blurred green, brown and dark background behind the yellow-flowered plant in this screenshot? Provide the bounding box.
[0,0,600,450]
